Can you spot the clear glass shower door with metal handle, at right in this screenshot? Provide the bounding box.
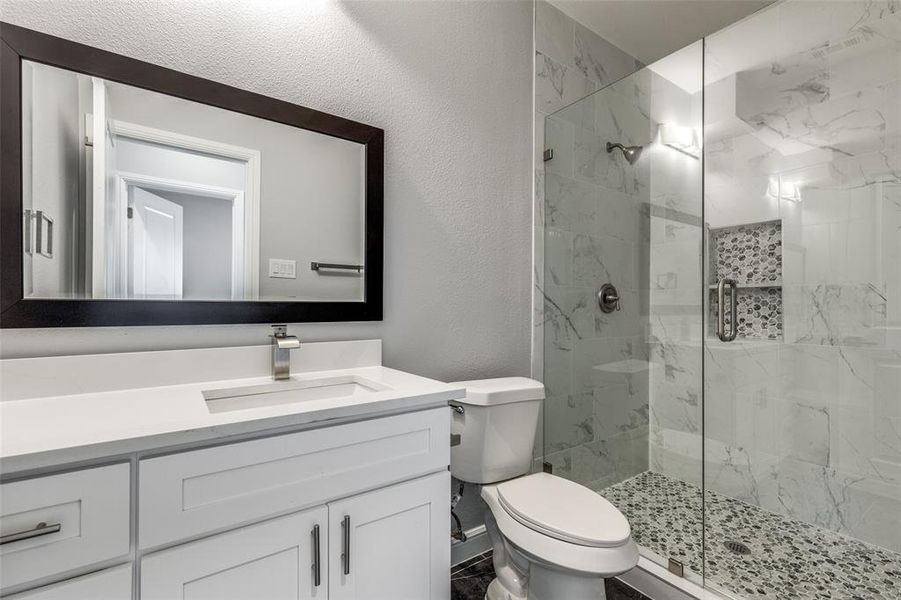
[704,0,901,599]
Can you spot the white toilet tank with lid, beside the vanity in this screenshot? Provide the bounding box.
[451,377,544,483]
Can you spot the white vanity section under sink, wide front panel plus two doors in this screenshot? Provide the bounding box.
[138,408,450,600]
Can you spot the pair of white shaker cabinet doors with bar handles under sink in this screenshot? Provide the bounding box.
[140,472,450,600]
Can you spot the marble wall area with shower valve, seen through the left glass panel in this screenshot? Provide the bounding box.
[543,76,650,487]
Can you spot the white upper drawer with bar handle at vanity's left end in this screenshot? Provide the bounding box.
[0,463,131,589]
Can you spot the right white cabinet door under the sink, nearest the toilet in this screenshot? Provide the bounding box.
[328,472,450,600]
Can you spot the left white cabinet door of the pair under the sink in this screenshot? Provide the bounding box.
[141,506,328,600]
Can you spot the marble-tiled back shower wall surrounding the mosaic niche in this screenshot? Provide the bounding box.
[652,0,901,551]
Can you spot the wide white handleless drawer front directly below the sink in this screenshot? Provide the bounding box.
[138,408,450,548]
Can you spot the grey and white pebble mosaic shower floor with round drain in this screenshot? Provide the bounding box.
[600,471,901,600]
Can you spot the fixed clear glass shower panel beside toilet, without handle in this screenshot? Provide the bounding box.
[542,42,703,581]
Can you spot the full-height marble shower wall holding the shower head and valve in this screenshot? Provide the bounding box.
[532,0,647,483]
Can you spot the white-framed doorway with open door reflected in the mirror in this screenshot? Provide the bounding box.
[88,92,260,300]
